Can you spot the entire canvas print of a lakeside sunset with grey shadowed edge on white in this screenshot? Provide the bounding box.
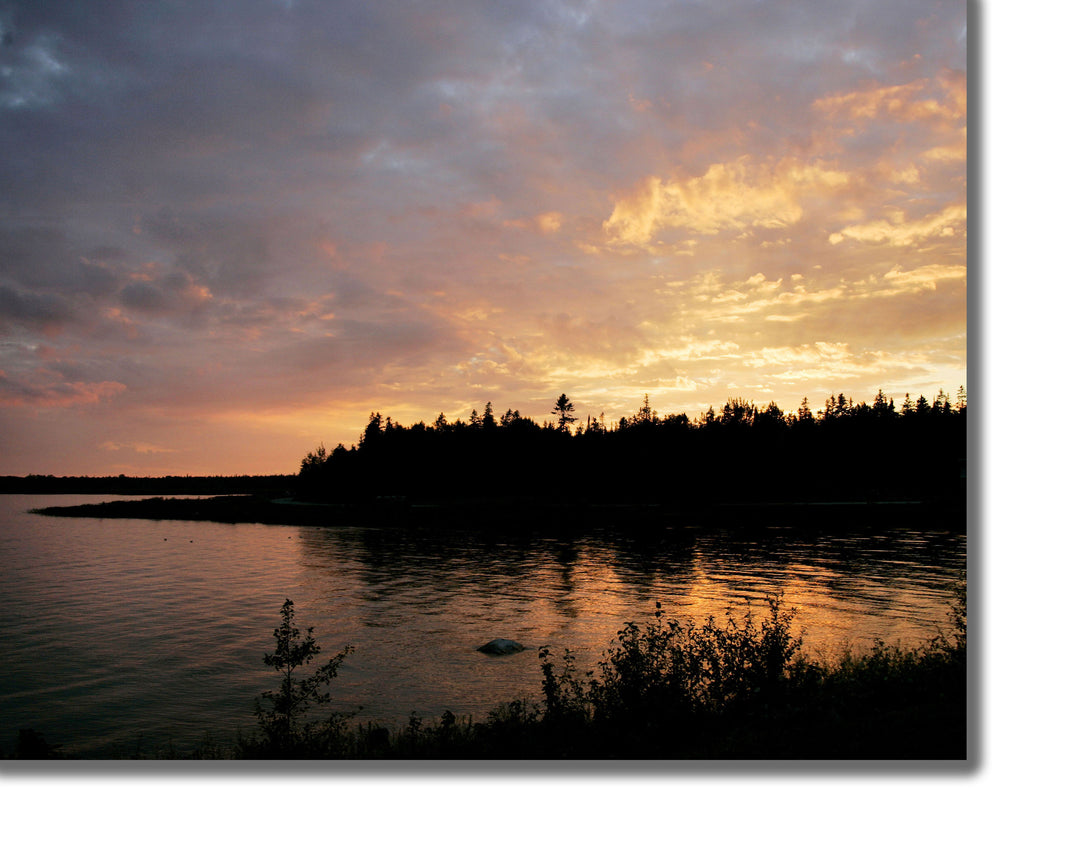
[0,0,977,763]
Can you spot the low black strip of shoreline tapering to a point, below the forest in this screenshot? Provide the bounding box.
[30,494,964,530]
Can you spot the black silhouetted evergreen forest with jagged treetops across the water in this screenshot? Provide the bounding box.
[297,387,968,503]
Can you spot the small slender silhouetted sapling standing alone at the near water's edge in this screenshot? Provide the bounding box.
[255,598,353,756]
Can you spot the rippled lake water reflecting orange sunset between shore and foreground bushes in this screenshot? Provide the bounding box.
[0,495,967,757]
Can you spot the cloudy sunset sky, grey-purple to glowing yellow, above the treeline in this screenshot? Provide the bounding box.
[0,0,968,475]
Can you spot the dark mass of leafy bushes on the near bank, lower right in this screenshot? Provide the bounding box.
[274,590,967,759]
